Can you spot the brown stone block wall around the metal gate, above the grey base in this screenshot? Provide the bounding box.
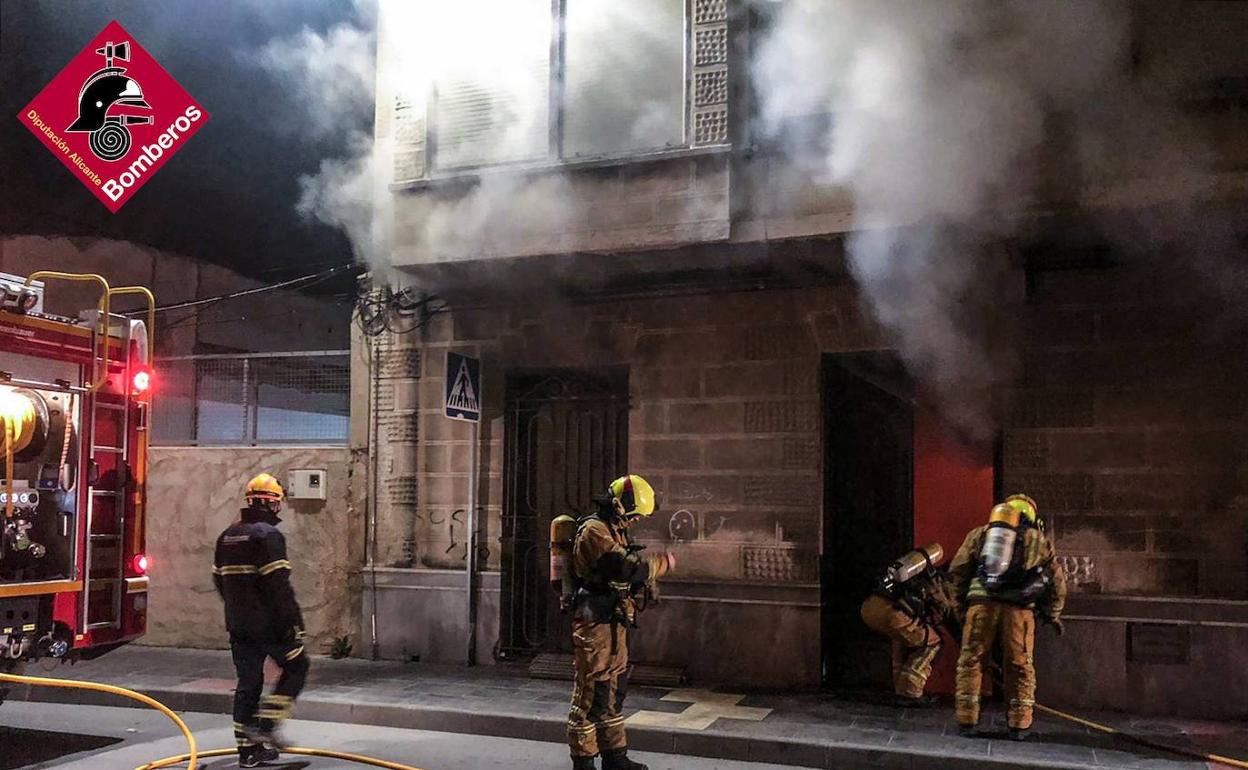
[361,279,879,582]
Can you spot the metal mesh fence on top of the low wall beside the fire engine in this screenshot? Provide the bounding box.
[152,351,351,447]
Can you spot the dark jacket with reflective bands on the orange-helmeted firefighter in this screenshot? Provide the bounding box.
[212,511,303,644]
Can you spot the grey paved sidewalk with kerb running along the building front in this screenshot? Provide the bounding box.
[0,646,1248,770]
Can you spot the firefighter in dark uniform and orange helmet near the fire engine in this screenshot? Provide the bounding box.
[212,473,308,768]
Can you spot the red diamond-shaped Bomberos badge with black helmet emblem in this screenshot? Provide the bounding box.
[17,21,208,212]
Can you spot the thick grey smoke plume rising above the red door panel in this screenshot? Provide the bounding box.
[754,0,1198,437]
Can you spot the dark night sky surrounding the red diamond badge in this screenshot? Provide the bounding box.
[0,0,366,281]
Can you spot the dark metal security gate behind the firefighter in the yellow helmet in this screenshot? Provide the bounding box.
[499,369,628,656]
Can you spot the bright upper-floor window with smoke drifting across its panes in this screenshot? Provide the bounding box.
[406,0,689,170]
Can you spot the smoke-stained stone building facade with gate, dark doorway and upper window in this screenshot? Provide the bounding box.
[352,0,1248,715]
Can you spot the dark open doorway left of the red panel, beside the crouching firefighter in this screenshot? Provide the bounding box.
[820,352,915,688]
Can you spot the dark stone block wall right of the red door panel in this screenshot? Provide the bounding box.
[1002,268,1248,599]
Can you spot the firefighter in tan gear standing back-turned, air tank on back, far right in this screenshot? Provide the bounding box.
[950,494,1066,740]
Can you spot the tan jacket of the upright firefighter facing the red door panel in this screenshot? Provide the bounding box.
[948,525,1066,620]
